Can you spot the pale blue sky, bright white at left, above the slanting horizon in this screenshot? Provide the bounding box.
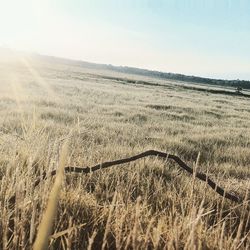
[0,0,250,80]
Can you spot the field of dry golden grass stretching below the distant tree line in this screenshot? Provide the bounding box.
[0,53,250,249]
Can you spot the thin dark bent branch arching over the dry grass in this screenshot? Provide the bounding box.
[31,150,242,203]
